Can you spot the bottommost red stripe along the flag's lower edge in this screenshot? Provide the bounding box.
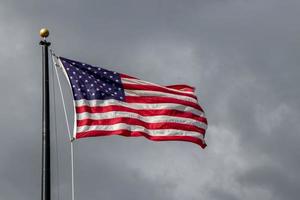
[76,129,206,149]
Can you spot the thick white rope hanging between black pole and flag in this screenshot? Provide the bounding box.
[50,49,75,200]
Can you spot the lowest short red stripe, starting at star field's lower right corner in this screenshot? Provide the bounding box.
[125,96,203,112]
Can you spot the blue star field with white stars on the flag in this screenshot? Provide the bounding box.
[60,57,125,101]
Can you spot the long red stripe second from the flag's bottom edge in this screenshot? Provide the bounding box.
[77,117,205,134]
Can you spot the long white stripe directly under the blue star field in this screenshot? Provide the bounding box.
[75,99,205,117]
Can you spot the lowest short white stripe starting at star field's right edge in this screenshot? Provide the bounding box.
[125,89,198,103]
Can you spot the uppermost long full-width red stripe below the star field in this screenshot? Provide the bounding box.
[76,105,207,124]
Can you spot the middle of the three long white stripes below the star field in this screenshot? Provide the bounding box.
[77,111,207,129]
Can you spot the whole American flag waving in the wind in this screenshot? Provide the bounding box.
[59,57,207,148]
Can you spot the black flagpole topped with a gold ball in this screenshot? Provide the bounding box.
[40,28,51,200]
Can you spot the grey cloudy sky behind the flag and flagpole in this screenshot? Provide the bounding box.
[0,0,300,200]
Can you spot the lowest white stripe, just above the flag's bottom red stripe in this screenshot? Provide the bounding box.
[77,123,203,140]
